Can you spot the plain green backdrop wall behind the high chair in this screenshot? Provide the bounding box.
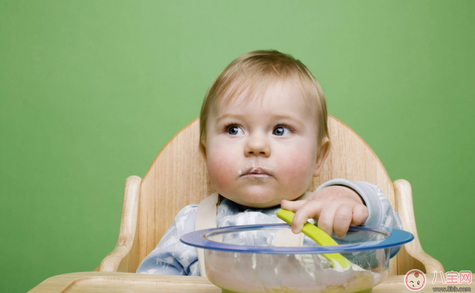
[0,0,475,292]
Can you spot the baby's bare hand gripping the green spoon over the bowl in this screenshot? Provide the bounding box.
[281,186,368,238]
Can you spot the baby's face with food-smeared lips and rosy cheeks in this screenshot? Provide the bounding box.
[203,82,317,208]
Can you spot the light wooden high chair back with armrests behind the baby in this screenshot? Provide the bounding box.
[96,115,443,275]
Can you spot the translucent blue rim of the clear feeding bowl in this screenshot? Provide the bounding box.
[180,223,414,254]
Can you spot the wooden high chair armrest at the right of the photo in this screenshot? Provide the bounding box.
[394,179,444,275]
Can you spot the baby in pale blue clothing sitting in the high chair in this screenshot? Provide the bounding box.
[137,51,402,276]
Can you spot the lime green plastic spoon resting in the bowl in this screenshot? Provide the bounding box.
[277,210,353,269]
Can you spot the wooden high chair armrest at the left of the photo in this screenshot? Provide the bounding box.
[96,176,142,272]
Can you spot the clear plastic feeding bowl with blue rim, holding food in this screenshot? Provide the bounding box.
[184,224,414,293]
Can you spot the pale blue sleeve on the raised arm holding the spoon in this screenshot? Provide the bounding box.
[315,178,403,258]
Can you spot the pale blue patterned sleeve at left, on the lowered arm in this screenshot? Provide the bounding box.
[137,205,200,276]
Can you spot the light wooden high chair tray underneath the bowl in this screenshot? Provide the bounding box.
[30,272,462,293]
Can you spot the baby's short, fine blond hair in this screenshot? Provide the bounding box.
[200,50,330,151]
